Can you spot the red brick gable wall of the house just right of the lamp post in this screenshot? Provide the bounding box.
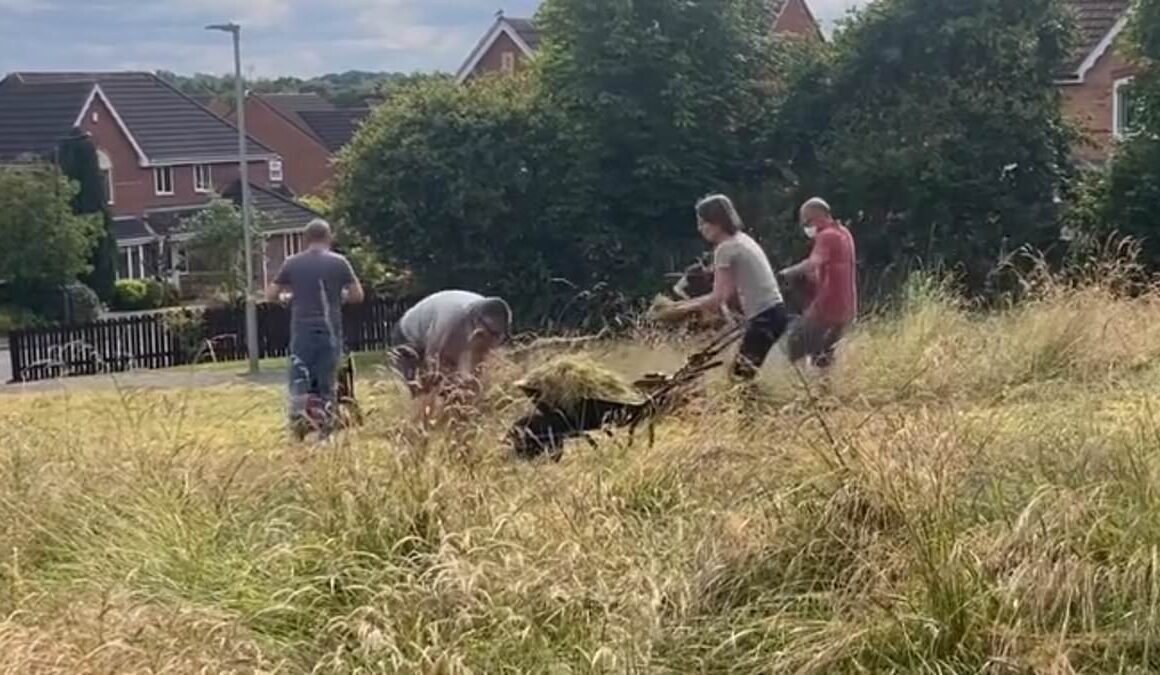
[237,99,334,195]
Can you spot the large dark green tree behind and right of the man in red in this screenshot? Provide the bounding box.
[775,0,1071,290]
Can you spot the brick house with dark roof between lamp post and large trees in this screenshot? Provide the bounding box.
[229,94,370,195]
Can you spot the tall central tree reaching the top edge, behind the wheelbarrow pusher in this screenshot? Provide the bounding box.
[536,0,780,292]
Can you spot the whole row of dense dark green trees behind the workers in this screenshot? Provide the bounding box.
[338,0,1071,320]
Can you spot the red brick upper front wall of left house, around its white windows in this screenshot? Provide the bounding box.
[81,92,269,217]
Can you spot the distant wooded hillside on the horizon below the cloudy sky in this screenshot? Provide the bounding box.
[157,71,407,106]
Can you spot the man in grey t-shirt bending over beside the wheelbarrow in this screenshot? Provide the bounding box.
[393,290,512,397]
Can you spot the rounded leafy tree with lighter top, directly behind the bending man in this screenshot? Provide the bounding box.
[335,78,583,320]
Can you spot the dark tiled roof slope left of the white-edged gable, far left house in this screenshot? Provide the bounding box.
[0,78,93,160]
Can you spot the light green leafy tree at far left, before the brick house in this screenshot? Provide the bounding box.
[0,165,101,293]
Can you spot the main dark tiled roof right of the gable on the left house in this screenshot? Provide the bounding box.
[9,72,275,164]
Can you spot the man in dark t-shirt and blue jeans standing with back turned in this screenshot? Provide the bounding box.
[267,218,364,434]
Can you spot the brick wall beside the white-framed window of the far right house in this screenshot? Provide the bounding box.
[1060,44,1132,161]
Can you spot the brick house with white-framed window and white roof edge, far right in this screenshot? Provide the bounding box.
[1057,0,1132,162]
